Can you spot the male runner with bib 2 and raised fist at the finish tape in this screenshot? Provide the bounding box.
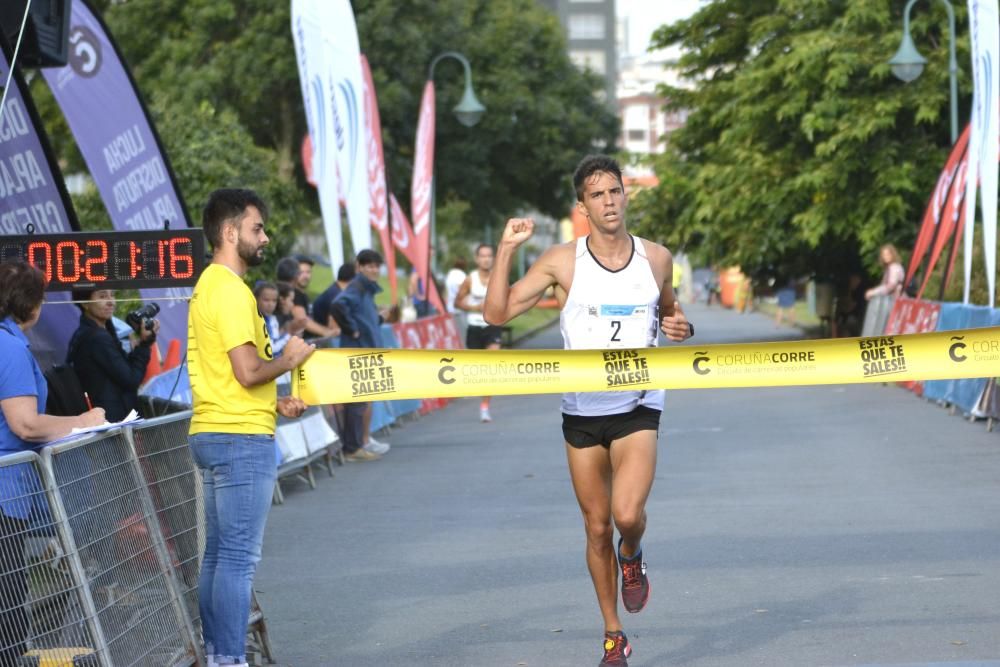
[483,155,694,666]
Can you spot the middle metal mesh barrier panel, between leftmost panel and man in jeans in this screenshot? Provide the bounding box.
[42,429,198,667]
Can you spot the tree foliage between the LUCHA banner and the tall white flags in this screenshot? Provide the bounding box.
[104,0,305,178]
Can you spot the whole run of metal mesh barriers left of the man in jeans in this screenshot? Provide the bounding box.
[0,411,286,667]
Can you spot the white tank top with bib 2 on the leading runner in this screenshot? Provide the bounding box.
[559,236,664,416]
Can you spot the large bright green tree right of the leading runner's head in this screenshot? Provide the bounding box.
[634,0,971,292]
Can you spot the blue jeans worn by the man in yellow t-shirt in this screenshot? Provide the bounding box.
[190,433,277,665]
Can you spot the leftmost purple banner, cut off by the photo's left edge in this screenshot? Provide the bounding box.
[0,45,80,367]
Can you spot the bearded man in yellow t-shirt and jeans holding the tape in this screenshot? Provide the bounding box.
[188,189,316,666]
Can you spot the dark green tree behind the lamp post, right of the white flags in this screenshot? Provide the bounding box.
[354,0,618,239]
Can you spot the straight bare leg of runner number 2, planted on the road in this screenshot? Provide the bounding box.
[566,443,622,632]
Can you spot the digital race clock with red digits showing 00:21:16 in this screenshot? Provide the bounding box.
[0,229,205,291]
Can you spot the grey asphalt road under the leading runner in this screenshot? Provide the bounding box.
[256,306,1000,667]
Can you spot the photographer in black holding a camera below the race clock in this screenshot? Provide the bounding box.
[66,289,160,422]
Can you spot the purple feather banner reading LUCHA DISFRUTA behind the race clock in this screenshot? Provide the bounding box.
[41,0,191,348]
